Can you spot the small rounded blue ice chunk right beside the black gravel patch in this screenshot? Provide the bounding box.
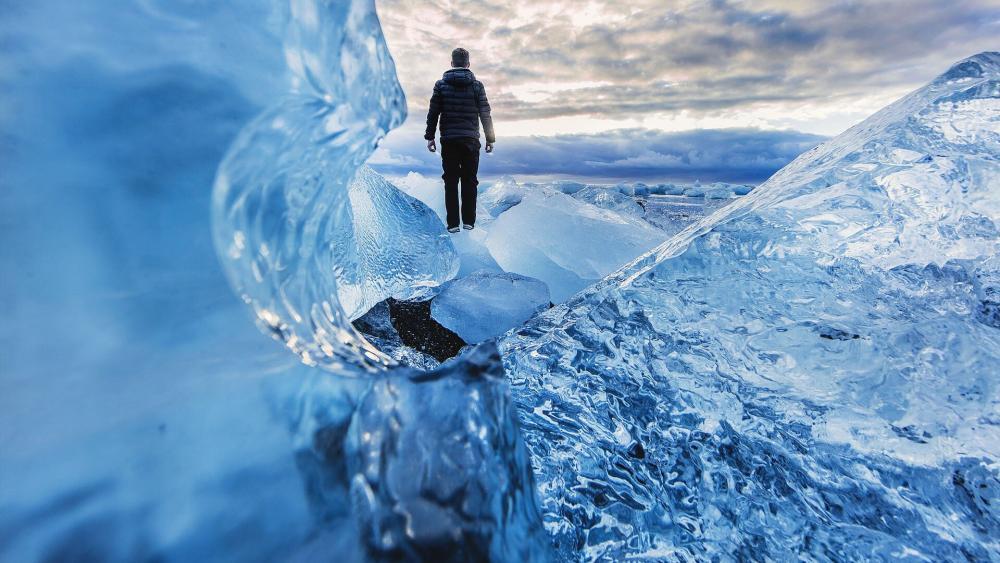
[431,271,549,343]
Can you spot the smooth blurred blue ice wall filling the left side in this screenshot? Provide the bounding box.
[0,0,541,562]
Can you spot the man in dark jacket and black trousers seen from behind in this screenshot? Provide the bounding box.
[424,47,496,233]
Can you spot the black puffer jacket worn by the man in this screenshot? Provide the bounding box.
[424,68,496,143]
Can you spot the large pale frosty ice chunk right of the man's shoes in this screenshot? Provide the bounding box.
[486,188,666,302]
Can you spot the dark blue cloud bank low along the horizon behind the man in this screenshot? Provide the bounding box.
[372,127,824,183]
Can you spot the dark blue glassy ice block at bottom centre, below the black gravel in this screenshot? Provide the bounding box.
[344,343,548,562]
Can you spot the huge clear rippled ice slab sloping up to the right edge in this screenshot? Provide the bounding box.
[501,53,1000,561]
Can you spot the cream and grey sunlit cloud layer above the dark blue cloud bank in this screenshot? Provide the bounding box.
[379,0,1000,132]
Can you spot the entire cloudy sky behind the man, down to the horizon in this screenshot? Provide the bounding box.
[371,0,1000,183]
